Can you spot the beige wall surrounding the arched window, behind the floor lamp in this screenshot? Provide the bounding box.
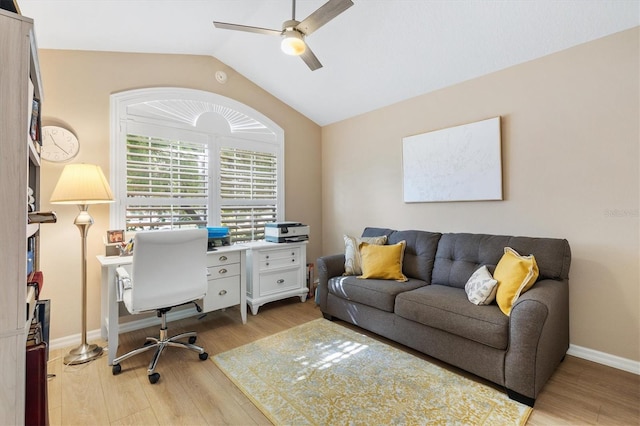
[40,50,321,339]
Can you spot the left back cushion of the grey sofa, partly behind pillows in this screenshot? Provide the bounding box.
[362,228,442,287]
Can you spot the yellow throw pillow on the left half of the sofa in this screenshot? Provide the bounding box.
[358,241,408,282]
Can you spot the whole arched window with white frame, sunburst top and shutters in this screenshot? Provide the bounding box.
[110,88,284,242]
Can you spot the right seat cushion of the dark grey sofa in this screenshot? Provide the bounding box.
[395,285,509,350]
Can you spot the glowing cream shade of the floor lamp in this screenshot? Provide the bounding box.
[50,164,113,205]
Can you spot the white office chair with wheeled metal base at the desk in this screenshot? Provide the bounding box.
[112,229,209,383]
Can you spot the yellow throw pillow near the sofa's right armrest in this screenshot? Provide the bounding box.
[493,247,538,316]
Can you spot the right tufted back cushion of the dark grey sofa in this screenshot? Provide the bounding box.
[431,233,571,288]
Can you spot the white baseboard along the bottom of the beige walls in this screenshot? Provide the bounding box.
[49,322,640,375]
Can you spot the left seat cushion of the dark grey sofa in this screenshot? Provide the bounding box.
[327,275,424,316]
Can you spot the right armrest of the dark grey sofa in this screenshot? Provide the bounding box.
[504,279,569,405]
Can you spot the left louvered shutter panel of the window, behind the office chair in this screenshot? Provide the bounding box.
[125,134,209,231]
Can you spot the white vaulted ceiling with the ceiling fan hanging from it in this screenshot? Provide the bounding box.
[18,0,640,125]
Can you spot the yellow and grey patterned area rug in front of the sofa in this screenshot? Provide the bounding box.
[212,319,531,425]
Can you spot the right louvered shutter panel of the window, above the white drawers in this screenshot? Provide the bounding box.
[220,147,278,241]
